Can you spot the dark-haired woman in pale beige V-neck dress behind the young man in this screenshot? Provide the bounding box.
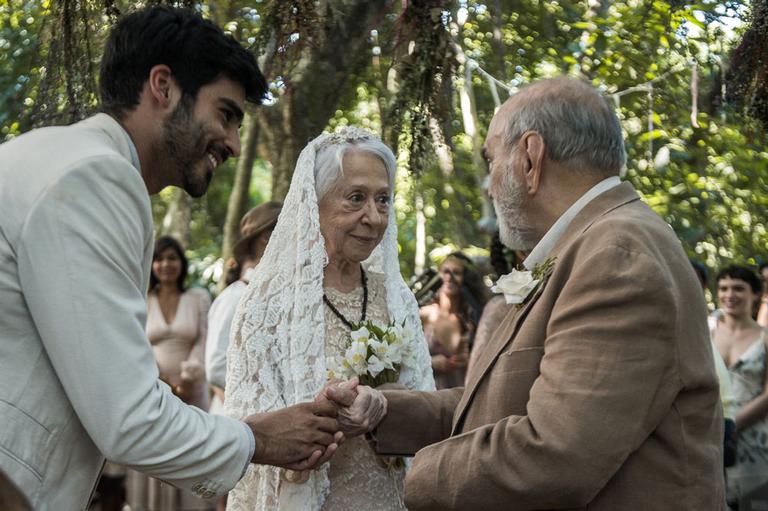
[126,236,215,511]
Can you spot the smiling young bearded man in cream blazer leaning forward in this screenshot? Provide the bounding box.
[0,7,341,511]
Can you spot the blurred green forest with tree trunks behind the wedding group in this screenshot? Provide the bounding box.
[0,0,768,294]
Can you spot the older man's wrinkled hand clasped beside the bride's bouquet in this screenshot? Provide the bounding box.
[327,385,387,437]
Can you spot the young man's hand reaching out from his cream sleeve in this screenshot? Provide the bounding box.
[245,399,344,470]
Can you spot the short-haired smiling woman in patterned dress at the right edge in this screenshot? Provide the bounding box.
[712,266,768,502]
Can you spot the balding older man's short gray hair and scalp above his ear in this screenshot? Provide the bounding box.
[504,77,627,175]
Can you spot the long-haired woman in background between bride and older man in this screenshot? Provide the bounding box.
[419,252,488,389]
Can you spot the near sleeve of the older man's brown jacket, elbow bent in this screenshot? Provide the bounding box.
[406,246,681,511]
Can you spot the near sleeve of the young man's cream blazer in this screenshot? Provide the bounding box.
[18,156,252,497]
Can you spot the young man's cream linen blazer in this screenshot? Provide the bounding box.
[0,114,251,511]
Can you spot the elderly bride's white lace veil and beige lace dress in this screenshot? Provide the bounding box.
[224,128,435,511]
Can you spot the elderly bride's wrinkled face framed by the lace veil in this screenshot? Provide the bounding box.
[319,149,390,263]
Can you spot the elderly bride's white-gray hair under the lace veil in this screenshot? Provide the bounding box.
[315,138,397,202]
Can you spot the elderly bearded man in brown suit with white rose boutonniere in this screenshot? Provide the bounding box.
[329,78,724,511]
